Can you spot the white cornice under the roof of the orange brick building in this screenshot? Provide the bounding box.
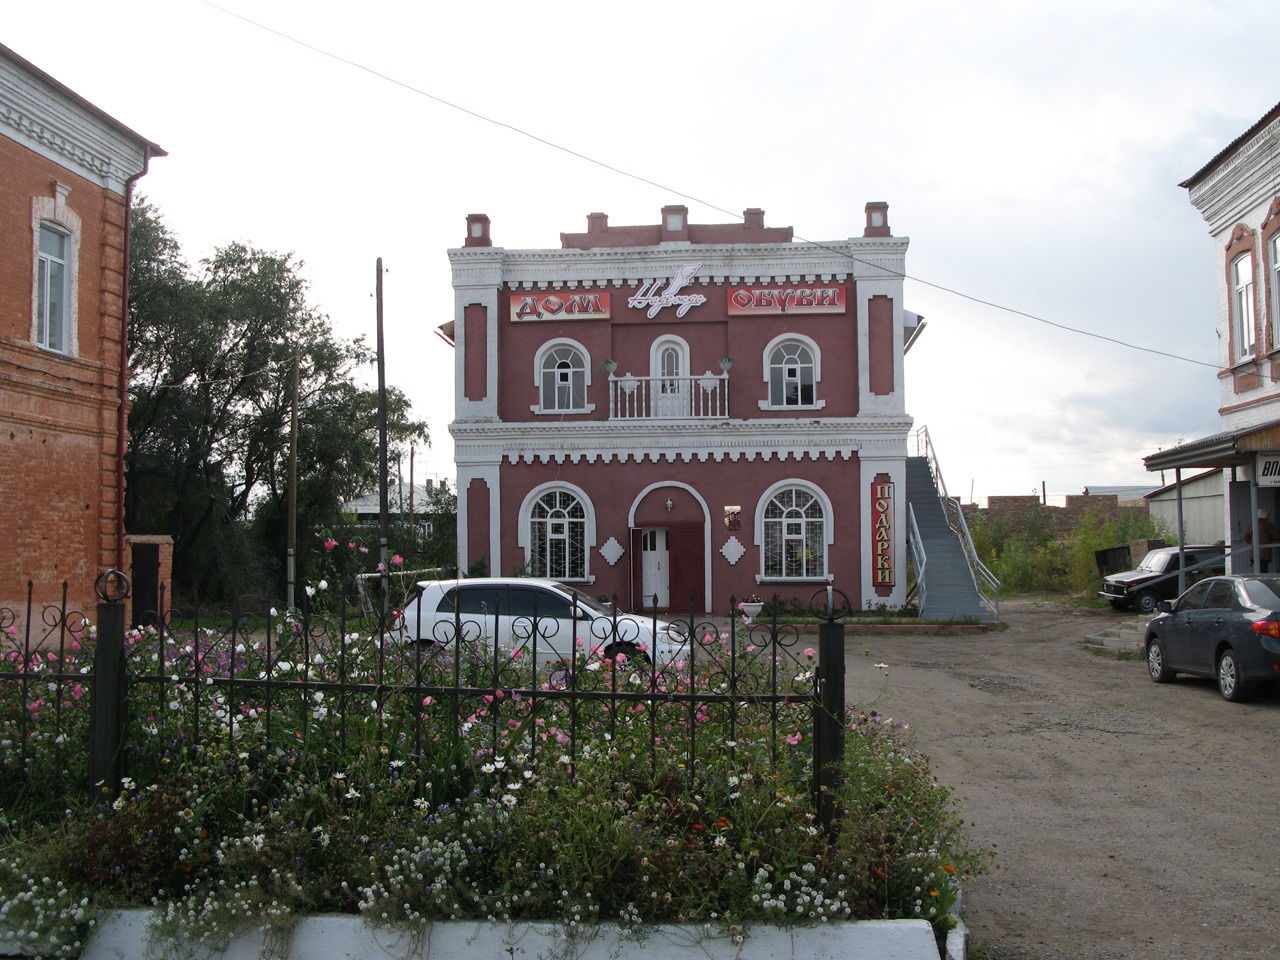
[0,47,165,196]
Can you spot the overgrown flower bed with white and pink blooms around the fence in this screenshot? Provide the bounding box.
[0,619,983,956]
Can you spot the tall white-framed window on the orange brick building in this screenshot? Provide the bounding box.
[31,193,81,357]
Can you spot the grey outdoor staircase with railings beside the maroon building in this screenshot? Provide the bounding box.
[906,428,1000,621]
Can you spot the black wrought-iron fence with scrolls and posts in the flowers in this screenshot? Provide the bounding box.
[0,579,845,822]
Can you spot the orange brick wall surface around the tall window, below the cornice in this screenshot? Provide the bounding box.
[0,136,127,614]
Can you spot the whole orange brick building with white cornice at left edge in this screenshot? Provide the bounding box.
[0,45,165,616]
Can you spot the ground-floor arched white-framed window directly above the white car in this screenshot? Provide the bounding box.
[517,483,595,584]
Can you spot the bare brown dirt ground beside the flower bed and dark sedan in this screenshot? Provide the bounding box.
[846,600,1280,960]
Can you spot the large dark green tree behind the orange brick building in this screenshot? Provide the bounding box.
[125,201,429,598]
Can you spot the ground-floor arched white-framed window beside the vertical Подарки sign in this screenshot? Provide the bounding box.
[755,479,835,582]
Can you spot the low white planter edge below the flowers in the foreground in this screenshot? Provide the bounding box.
[32,910,966,960]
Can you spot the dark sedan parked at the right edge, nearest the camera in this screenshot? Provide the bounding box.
[1147,573,1280,700]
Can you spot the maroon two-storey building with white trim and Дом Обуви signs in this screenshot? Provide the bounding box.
[444,204,920,613]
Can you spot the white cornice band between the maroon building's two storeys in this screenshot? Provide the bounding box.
[449,416,914,468]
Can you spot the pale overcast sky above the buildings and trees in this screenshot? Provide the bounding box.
[0,0,1280,500]
